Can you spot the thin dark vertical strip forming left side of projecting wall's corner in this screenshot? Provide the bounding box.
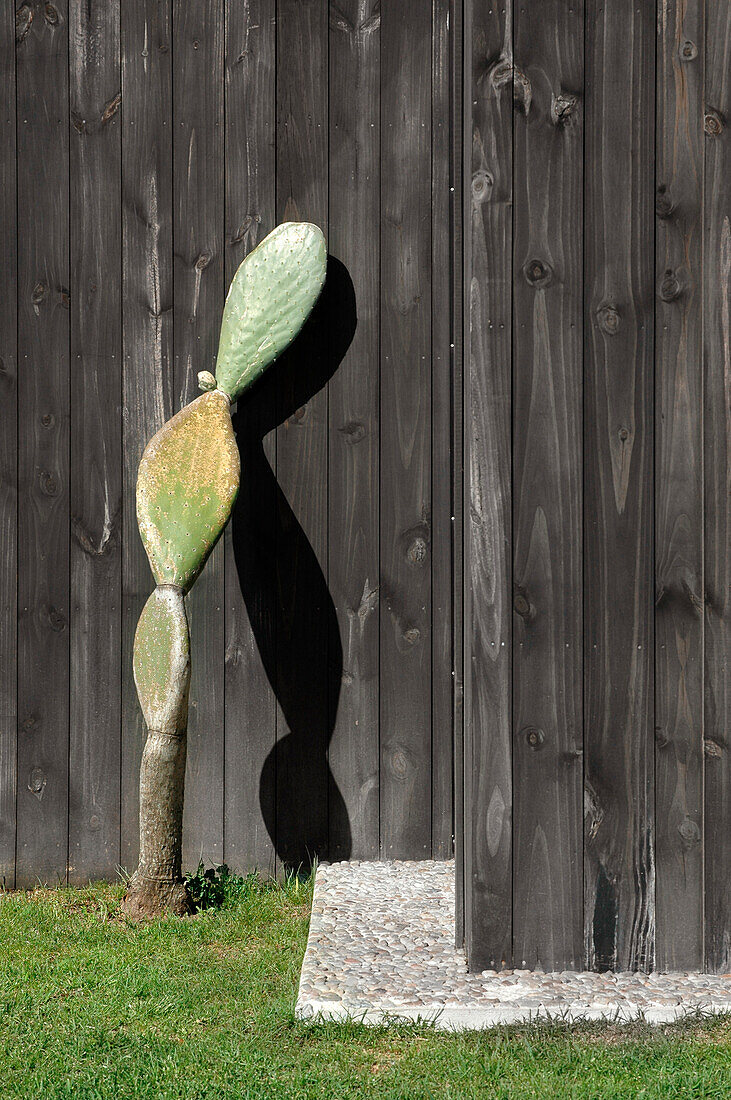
[448,0,468,947]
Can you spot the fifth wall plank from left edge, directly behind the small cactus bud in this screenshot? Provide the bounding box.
[173,0,224,867]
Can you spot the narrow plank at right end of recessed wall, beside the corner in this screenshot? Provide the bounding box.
[431,0,454,859]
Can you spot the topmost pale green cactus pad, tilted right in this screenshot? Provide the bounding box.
[215,221,328,402]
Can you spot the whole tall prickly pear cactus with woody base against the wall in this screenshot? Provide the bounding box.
[123,222,326,917]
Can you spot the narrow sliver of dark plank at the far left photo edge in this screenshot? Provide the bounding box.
[0,4,18,889]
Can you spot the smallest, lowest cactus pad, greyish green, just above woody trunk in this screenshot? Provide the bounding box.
[133,587,190,733]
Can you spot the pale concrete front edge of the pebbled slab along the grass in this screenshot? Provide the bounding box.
[295,994,731,1031]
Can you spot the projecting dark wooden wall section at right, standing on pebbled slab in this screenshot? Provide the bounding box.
[457,0,731,971]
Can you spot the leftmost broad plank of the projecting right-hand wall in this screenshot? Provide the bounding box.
[464,3,513,970]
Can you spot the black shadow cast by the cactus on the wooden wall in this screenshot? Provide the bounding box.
[226,256,356,870]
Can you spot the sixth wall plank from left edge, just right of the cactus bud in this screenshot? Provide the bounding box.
[224,0,276,871]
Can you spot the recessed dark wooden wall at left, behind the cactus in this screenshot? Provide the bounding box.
[0,0,454,887]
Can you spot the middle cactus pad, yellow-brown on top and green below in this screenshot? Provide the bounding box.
[137,389,240,592]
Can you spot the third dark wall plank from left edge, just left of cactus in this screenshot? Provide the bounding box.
[68,0,122,882]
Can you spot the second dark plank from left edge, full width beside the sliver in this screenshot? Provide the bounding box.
[15,0,69,887]
